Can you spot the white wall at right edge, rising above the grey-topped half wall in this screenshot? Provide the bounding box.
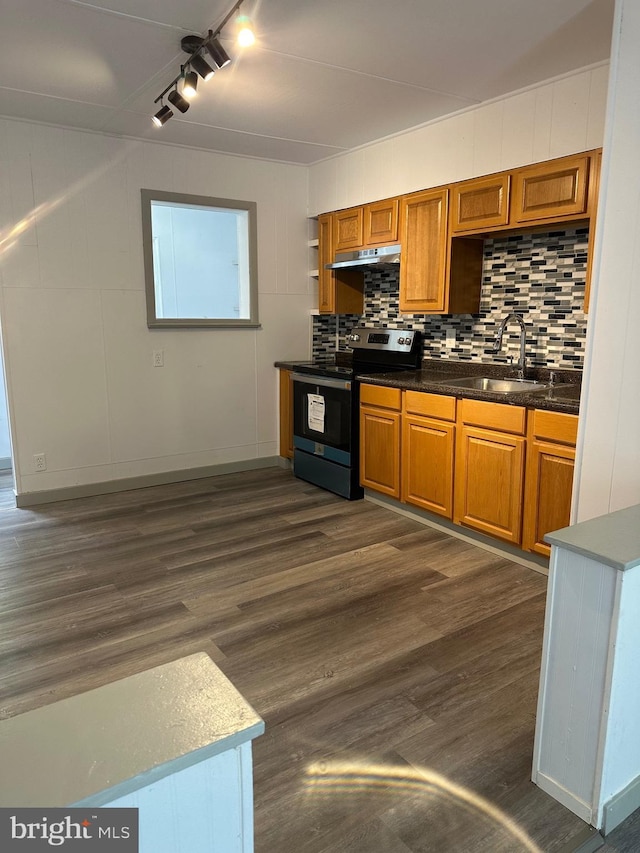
[573,0,640,521]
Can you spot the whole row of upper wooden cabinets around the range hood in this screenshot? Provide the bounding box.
[318,151,600,314]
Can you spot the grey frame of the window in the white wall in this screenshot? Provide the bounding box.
[140,189,260,329]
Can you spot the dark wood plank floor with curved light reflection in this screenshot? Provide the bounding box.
[0,469,640,853]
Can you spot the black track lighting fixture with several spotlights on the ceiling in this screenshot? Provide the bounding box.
[153,0,255,127]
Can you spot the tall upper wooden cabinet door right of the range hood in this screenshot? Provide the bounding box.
[400,189,448,313]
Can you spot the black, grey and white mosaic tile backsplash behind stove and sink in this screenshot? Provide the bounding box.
[313,228,589,369]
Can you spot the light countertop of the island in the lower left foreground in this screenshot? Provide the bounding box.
[0,652,264,808]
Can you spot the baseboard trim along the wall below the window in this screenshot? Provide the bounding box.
[16,456,279,509]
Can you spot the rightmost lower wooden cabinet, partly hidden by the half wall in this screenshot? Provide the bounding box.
[522,410,578,557]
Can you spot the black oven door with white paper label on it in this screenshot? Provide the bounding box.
[292,373,353,466]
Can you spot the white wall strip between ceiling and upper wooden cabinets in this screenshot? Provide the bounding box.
[309,65,608,214]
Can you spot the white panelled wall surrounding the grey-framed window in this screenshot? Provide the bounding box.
[0,120,315,494]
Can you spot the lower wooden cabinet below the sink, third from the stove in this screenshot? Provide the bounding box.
[454,400,526,545]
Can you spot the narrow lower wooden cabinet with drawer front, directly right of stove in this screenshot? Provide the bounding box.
[360,385,402,499]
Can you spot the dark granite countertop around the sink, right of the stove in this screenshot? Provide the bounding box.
[358,359,582,415]
